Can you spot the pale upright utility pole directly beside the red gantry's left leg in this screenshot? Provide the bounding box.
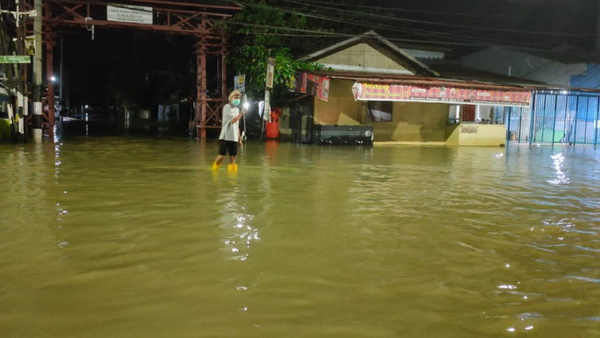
[32,0,42,143]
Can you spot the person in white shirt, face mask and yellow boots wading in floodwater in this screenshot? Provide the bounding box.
[212,90,246,171]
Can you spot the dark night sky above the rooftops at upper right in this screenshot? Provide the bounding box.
[373,0,600,62]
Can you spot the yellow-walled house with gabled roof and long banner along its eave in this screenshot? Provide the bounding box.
[279,32,531,146]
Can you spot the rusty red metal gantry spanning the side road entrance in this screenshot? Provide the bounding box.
[14,0,241,140]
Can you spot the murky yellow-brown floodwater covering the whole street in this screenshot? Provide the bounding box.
[0,137,600,337]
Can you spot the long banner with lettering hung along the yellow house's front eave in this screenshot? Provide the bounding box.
[352,82,531,106]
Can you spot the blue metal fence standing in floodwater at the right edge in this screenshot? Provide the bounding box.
[505,91,600,144]
